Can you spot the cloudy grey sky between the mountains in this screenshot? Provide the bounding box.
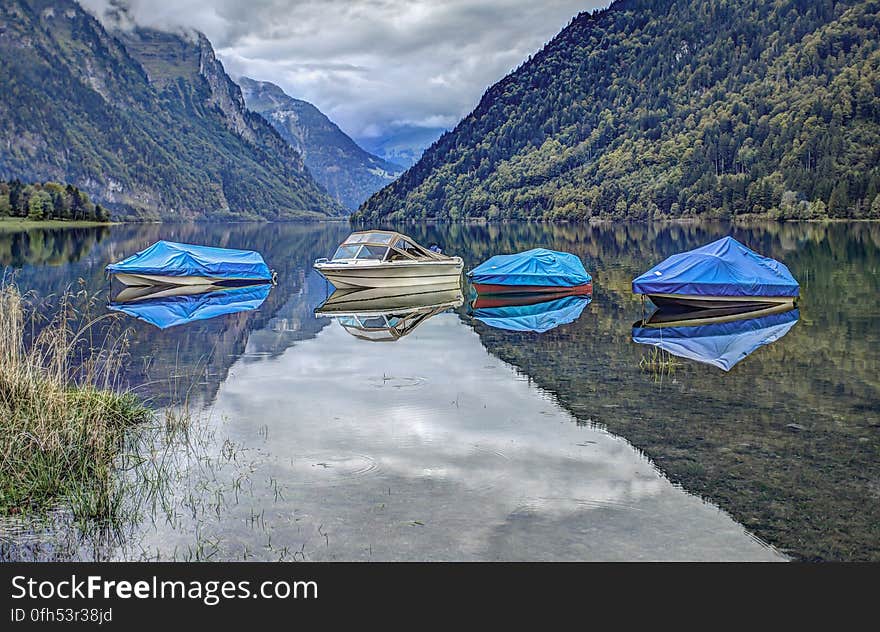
[81,0,609,138]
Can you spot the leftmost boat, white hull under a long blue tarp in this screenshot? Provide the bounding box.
[106,241,272,285]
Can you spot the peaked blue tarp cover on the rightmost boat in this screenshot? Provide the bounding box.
[633,237,799,297]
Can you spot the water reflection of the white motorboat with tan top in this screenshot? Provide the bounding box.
[315,285,464,342]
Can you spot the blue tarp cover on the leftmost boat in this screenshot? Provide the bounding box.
[107,241,272,281]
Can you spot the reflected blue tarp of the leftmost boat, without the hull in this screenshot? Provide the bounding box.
[109,283,272,329]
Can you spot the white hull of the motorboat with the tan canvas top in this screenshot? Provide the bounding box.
[315,257,464,289]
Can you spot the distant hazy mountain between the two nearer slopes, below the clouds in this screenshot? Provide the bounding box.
[238,77,403,211]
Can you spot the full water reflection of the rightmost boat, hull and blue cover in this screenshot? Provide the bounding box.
[632,304,800,371]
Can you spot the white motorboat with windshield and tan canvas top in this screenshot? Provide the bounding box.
[314,230,464,289]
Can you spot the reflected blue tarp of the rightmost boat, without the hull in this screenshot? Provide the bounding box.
[633,309,800,371]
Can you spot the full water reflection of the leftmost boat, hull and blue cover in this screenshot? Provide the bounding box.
[108,283,272,329]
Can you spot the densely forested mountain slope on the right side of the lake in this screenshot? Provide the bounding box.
[356,0,880,220]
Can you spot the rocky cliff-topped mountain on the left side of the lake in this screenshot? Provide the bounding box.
[0,0,343,220]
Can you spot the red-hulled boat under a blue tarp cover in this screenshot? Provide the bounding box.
[468,248,593,294]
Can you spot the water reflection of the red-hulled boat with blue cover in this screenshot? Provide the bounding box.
[468,290,592,333]
